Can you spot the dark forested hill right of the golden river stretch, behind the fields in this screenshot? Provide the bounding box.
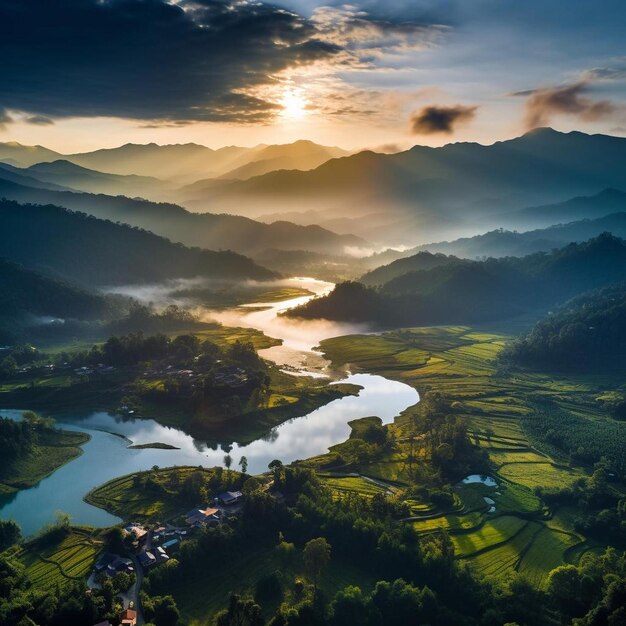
[288,234,626,326]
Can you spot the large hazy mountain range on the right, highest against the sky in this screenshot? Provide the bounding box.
[184,128,626,244]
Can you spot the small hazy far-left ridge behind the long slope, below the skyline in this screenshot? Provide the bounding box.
[24,159,168,197]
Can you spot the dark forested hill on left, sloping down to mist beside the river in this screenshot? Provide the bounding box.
[0,200,275,286]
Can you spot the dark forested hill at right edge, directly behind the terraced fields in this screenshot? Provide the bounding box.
[503,283,626,372]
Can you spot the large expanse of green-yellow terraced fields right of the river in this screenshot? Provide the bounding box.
[321,326,626,587]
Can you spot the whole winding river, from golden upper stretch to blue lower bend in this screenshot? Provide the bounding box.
[0,278,419,535]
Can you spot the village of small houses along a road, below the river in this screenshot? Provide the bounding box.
[87,491,244,626]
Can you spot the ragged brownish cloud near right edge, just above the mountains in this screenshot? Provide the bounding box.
[513,81,615,128]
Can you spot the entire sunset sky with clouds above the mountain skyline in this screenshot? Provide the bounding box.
[0,0,626,153]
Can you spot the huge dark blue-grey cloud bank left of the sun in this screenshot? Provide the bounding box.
[0,0,341,123]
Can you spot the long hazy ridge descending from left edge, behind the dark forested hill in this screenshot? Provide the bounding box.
[0,169,368,254]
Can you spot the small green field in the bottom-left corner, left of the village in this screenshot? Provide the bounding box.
[17,528,102,587]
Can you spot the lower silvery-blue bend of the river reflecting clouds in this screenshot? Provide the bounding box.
[0,374,419,535]
